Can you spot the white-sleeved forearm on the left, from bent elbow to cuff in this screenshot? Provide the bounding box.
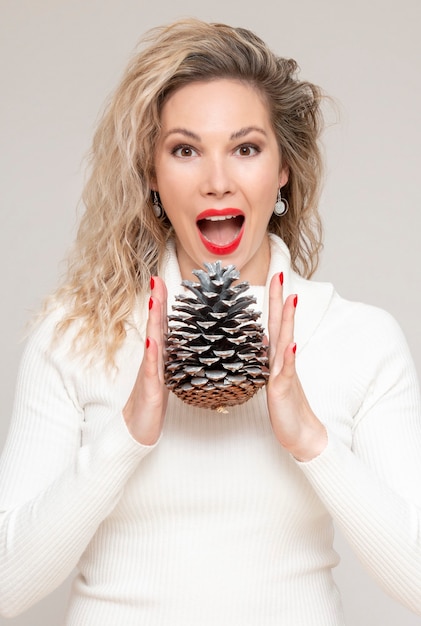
[0,416,152,617]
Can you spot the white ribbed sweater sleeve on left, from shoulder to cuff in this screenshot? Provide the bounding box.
[0,312,156,617]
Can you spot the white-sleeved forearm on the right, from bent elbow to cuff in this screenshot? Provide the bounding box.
[299,434,421,614]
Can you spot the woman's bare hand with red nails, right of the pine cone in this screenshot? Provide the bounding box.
[267,274,327,461]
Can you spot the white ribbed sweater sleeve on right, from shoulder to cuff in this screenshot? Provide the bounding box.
[299,312,421,614]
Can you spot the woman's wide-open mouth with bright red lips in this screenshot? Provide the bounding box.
[196,209,244,254]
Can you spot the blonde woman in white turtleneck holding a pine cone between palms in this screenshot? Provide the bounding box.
[0,20,421,626]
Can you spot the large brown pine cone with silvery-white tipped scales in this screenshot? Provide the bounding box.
[165,261,269,412]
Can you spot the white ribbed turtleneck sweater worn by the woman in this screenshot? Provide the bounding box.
[0,237,421,626]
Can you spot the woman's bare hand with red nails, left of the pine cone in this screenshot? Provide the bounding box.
[123,276,168,445]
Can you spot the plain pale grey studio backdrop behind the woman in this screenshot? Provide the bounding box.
[0,0,421,626]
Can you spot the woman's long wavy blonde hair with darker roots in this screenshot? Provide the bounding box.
[54,19,322,363]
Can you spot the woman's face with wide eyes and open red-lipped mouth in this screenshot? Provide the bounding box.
[152,79,288,284]
